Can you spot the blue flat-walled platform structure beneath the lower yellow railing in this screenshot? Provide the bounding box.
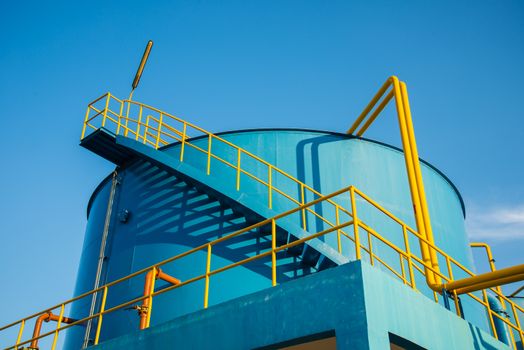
[94,261,509,350]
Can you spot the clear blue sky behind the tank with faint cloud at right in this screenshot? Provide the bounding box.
[0,0,524,330]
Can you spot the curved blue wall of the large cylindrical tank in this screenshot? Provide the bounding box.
[68,130,486,349]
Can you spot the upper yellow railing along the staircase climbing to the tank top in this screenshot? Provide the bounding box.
[81,92,360,253]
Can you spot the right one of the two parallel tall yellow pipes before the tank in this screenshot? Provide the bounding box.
[400,82,442,284]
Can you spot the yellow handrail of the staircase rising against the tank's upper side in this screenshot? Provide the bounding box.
[81,93,354,238]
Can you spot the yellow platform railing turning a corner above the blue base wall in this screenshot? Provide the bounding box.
[0,186,524,349]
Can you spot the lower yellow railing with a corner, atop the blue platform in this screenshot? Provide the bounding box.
[0,186,524,349]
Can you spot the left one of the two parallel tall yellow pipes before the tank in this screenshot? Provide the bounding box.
[390,77,435,286]
